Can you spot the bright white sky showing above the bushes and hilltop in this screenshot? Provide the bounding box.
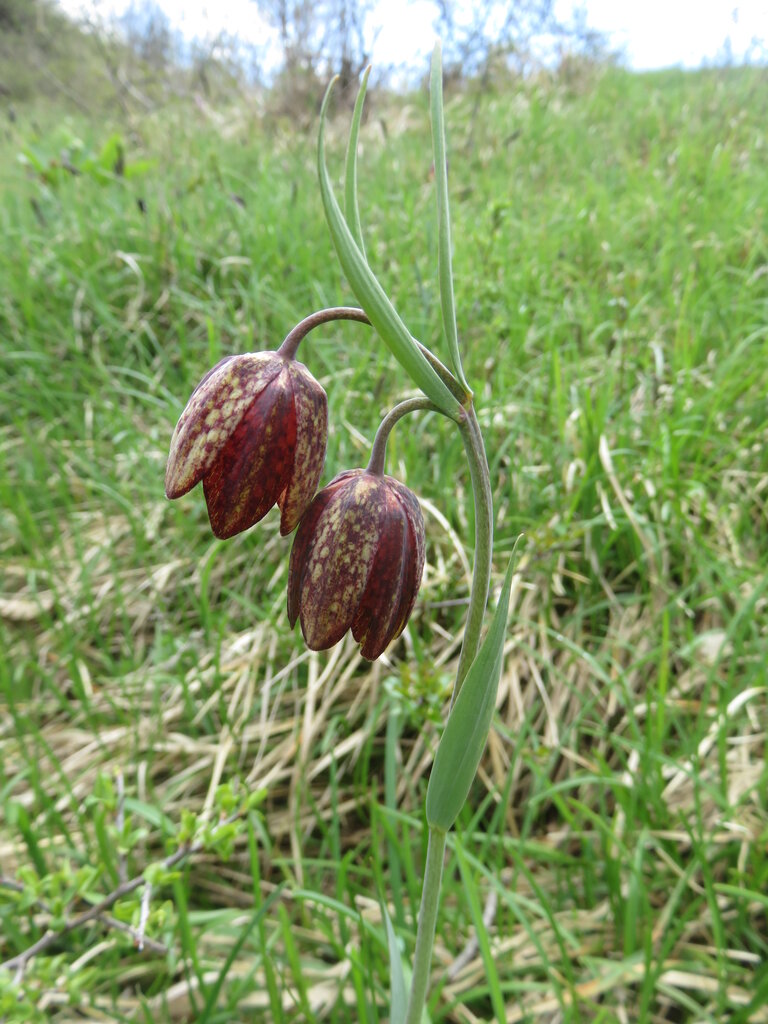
[58,0,768,70]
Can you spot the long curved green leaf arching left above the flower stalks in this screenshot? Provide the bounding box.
[317,79,462,420]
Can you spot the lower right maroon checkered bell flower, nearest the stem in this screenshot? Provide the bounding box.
[288,469,424,662]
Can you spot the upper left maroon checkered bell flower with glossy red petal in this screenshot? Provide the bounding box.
[165,352,328,539]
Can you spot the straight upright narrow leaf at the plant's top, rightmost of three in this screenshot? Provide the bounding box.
[429,40,472,394]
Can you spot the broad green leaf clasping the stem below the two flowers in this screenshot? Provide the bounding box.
[427,557,515,831]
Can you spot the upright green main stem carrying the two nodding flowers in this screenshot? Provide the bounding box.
[406,402,494,1024]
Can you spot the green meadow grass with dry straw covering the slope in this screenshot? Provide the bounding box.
[0,64,768,1024]
